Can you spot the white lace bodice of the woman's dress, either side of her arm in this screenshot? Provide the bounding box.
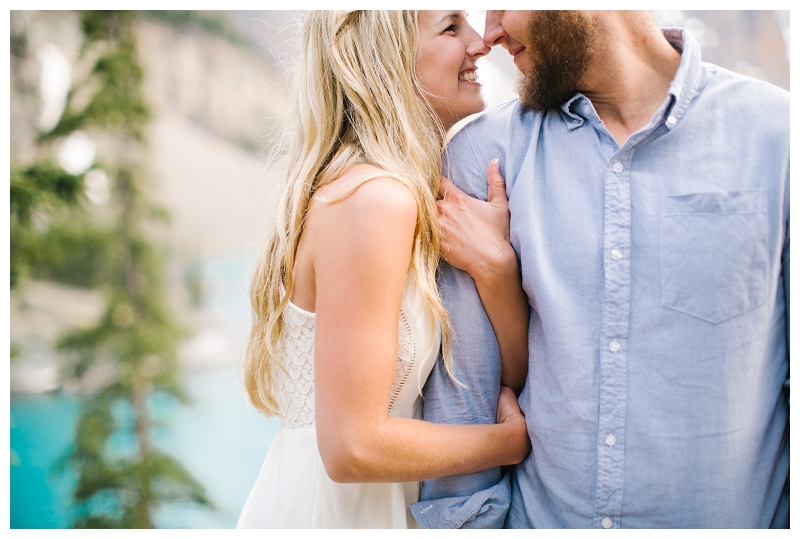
[275,285,438,429]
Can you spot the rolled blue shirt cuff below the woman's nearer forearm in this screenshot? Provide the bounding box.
[411,471,511,530]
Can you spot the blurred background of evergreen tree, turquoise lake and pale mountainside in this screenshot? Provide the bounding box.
[9,11,789,528]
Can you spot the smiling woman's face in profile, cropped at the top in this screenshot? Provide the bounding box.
[417,10,489,129]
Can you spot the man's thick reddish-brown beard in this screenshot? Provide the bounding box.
[517,11,594,110]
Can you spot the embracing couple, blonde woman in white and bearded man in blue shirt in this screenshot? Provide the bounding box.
[233,11,789,528]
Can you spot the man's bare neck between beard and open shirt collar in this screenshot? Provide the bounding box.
[581,16,681,146]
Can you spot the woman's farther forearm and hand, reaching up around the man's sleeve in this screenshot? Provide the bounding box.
[437,159,530,394]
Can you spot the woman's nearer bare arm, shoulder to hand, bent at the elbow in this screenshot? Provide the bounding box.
[303,171,530,482]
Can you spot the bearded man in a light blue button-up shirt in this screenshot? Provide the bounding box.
[413,11,789,528]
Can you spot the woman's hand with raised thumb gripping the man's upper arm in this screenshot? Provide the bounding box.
[436,159,517,281]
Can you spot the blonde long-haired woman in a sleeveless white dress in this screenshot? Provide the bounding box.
[237,11,530,528]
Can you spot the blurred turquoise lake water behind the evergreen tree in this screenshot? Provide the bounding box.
[9,257,279,528]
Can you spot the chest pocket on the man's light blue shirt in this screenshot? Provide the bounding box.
[660,191,768,324]
